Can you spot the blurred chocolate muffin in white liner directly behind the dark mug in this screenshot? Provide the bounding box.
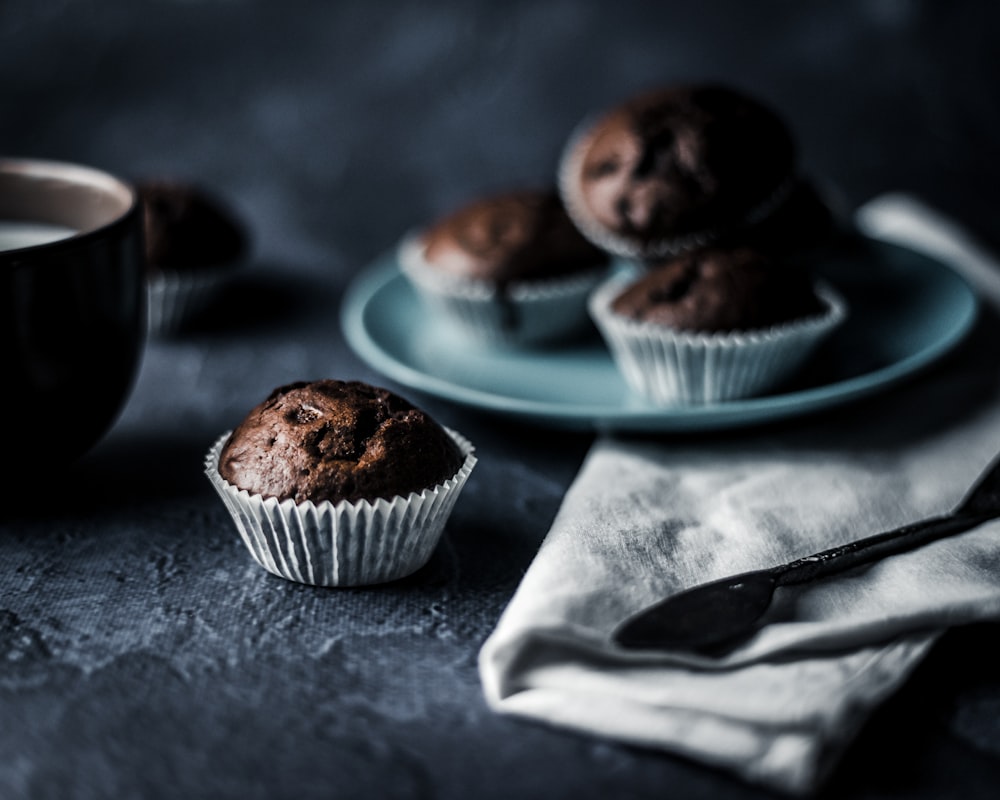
[136,179,249,335]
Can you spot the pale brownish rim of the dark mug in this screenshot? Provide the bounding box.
[0,156,139,260]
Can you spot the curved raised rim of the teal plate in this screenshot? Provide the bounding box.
[340,236,980,432]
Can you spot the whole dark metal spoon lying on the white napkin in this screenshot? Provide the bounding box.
[612,458,1000,653]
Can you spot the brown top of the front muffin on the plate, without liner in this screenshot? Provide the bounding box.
[611,247,825,333]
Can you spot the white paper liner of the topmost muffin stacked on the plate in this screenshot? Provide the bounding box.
[557,120,796,260]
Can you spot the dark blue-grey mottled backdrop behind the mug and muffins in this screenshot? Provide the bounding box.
[0,0,1000,269]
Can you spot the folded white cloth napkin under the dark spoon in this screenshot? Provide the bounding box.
[479,195,1000,794]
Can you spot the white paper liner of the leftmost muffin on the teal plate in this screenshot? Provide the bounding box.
[398,231,607,346]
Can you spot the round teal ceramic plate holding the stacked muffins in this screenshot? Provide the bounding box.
[341,240,977,432]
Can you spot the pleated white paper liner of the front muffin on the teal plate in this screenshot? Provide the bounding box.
[590,276,847,406]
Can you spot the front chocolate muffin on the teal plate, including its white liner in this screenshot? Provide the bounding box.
[590,247,846,406]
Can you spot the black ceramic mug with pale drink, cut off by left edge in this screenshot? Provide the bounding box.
[0,158,146,468]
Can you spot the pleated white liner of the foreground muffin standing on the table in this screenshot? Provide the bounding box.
[205,428,476,586]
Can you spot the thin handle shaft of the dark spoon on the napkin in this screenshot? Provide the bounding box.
[775,512,996,586]
